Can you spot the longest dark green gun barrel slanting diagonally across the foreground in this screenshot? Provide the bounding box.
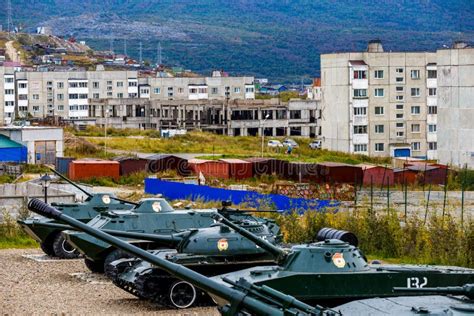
[28,199,330,316]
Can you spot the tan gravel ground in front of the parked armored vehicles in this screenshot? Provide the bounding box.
[0,249,218,315]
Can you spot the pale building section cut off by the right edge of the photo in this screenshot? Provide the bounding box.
[437,42,474,169]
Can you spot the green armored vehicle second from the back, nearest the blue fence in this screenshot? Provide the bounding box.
[63,198,280,272]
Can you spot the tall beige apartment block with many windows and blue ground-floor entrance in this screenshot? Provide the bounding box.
[321,41,438,159]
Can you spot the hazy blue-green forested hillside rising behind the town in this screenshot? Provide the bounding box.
[0,0,474,81]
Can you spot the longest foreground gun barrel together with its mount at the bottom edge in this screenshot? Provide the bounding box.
[28,199,339,316]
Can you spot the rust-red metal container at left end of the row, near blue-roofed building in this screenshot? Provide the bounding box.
[69,160,120,180]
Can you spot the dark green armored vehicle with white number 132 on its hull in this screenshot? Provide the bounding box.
[214,215,474,306]
